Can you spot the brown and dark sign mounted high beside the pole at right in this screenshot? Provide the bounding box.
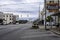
[47,1,59,12]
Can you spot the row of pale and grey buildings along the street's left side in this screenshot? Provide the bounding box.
[0,12,19,24]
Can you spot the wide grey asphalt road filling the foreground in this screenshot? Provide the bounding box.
[0,23,60,40]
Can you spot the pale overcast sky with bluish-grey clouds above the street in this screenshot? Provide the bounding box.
[0,0,44,17]
